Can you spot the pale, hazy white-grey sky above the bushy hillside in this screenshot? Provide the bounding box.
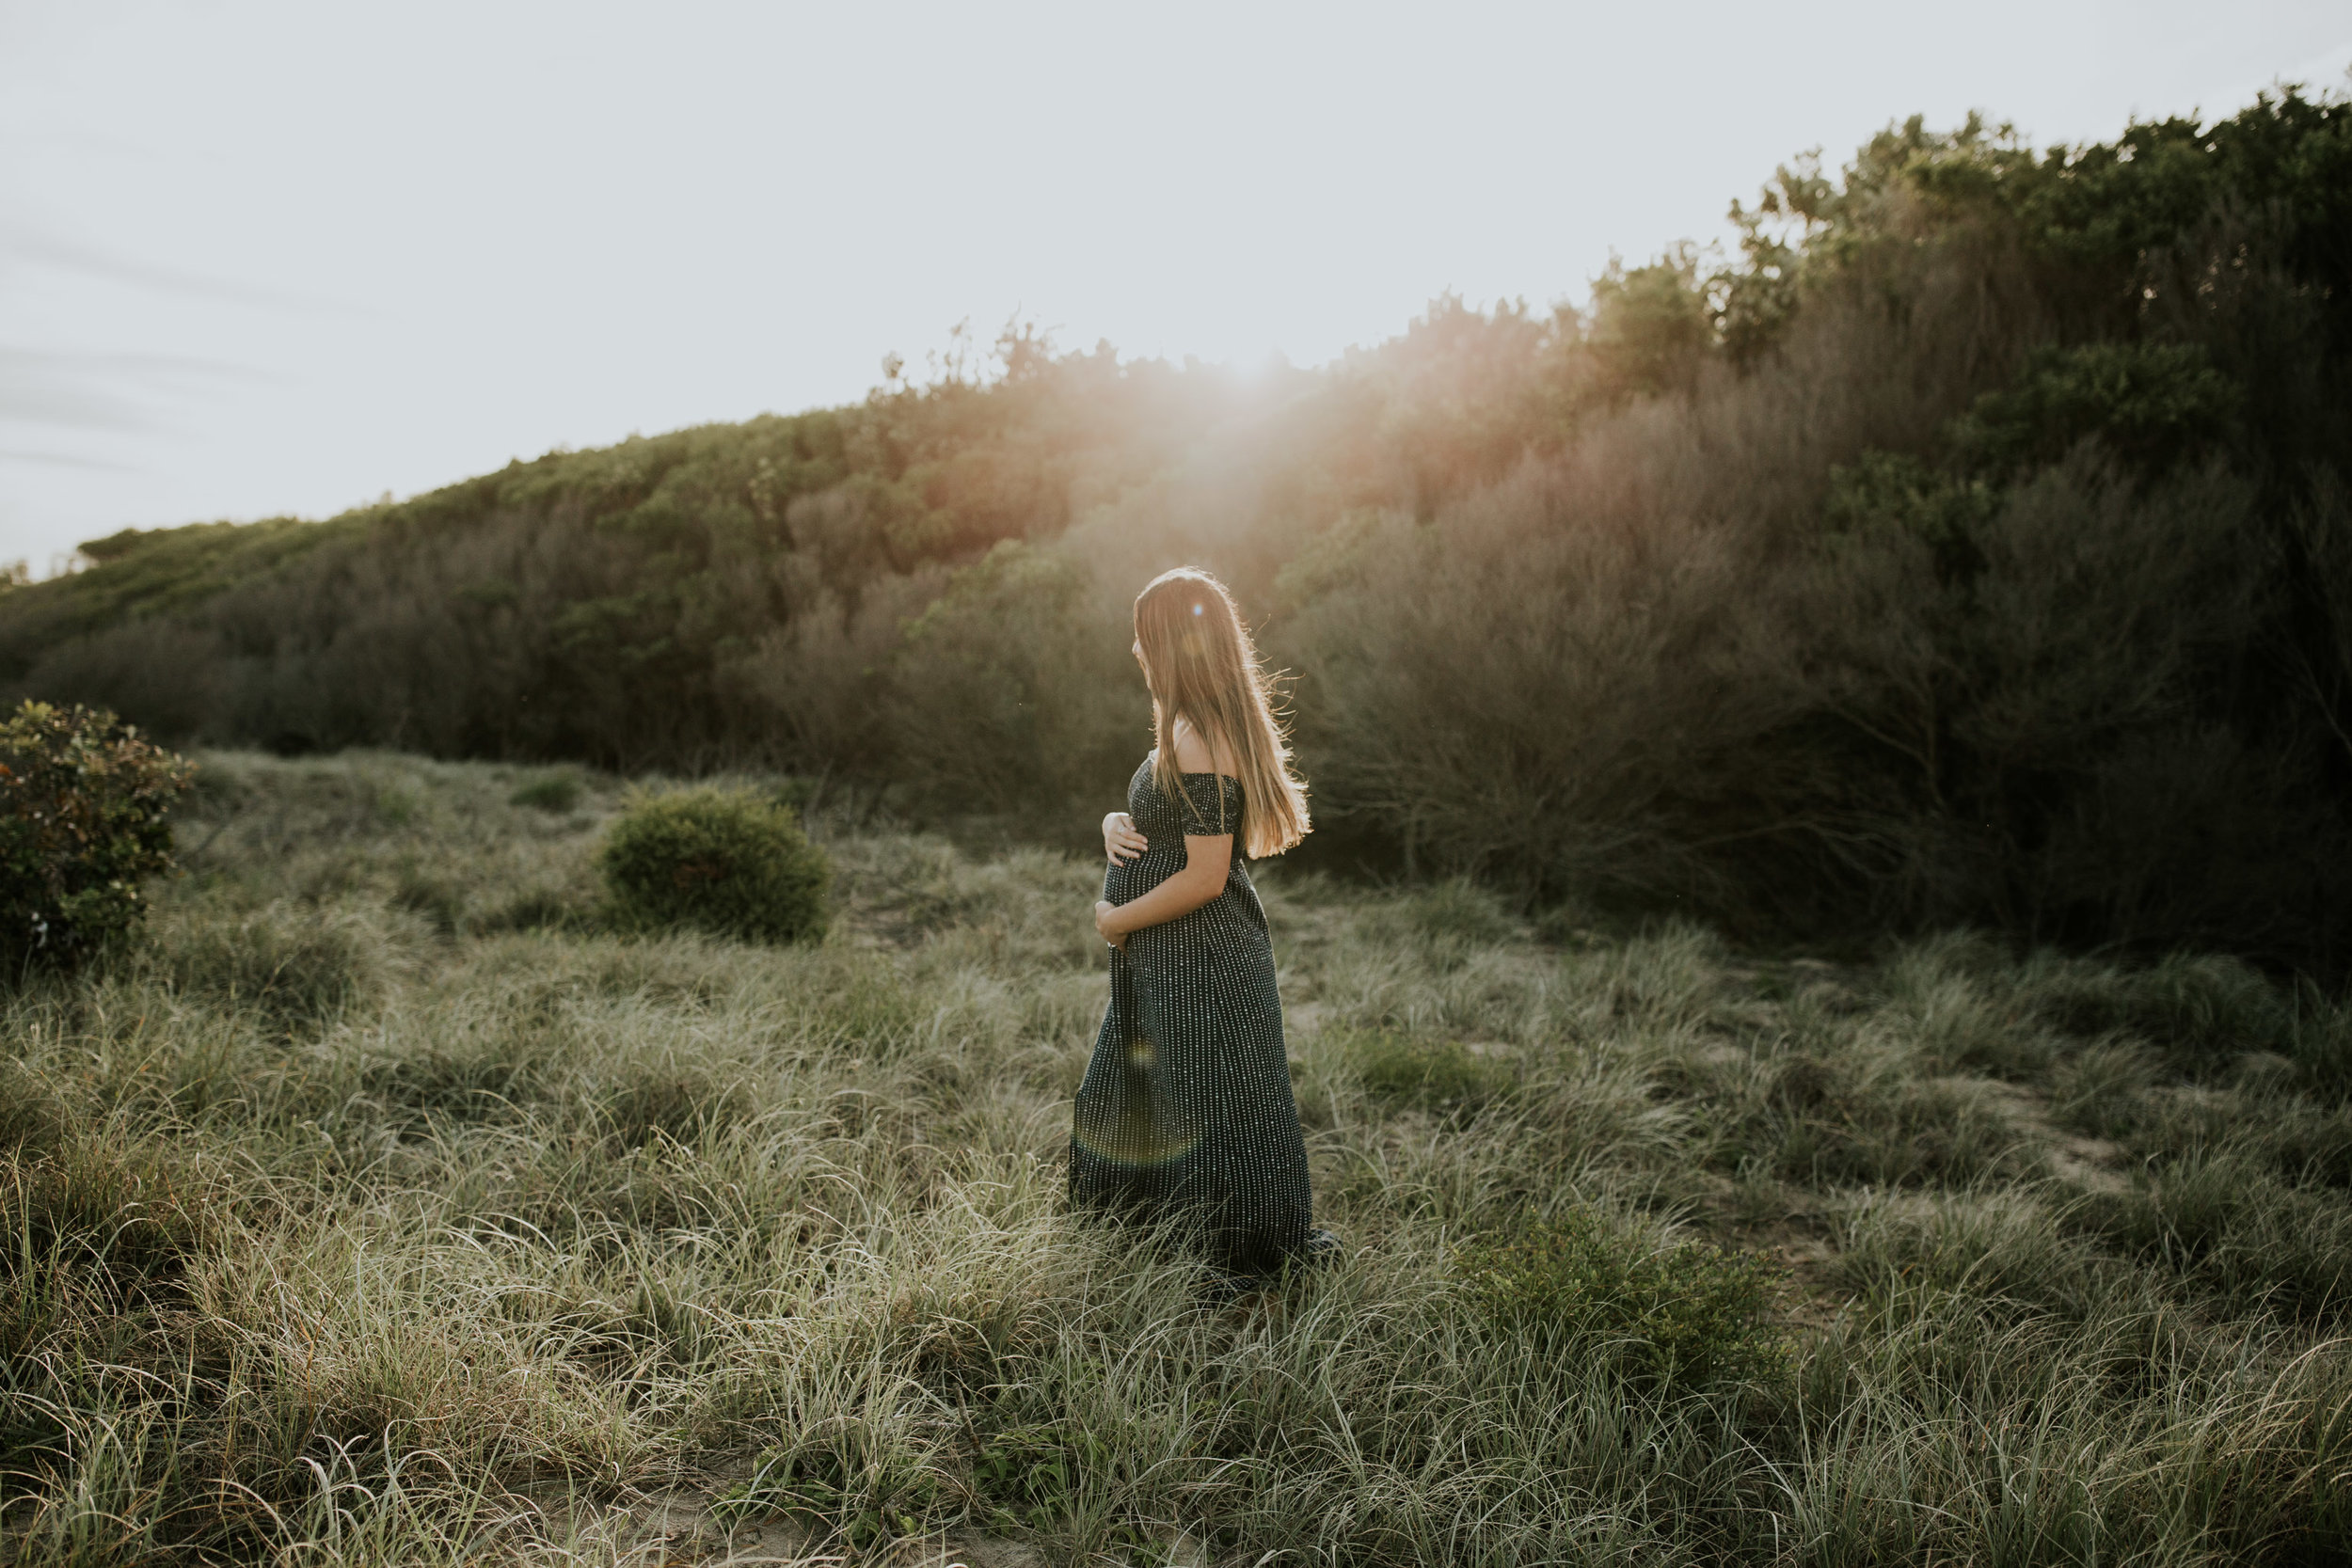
[0,0,2352,576]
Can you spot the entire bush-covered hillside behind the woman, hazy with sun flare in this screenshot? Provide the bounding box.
[13,94,2352,978]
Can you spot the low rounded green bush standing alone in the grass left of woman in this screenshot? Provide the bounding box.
[597,790,833,942]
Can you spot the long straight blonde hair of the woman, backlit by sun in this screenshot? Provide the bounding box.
[1136,566,1311,861]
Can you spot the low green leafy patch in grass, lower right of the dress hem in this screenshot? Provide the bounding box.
[1458,1209,1788,1392]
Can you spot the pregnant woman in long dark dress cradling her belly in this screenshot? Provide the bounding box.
[1071,566,1336,1293]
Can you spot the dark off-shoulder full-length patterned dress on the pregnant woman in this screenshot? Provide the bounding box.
[1071,757,1311,1275]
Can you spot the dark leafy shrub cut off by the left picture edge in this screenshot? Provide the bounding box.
[0,703,196,969]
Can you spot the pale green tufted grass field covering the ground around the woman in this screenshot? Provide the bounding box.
[0,754,2352,1566]
